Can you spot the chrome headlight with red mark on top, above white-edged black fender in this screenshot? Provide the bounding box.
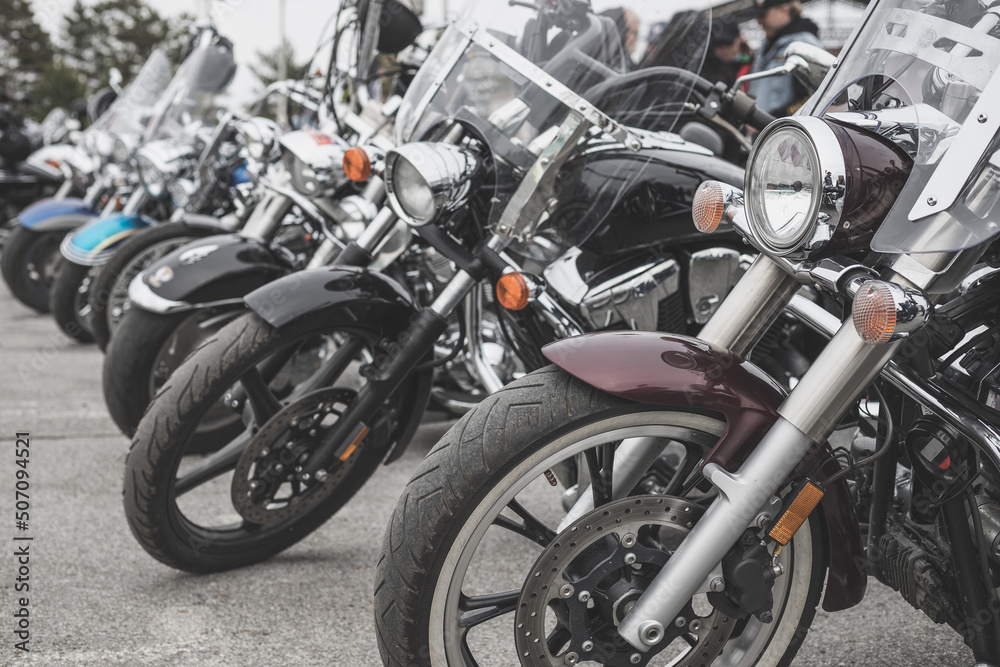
[278,130,348,197]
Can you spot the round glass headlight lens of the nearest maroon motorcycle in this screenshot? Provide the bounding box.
[747,126,822,251]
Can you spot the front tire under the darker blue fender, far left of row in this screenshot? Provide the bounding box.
[0,225,68,313]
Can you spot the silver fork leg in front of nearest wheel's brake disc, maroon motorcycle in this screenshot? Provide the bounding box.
[618,273,901,651]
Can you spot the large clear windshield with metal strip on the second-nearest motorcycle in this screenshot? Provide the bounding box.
[396,0,711,145]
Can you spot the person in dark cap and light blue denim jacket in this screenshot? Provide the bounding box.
[748,0,822,116]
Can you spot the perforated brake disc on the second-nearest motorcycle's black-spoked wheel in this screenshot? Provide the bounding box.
[232,388,359,525]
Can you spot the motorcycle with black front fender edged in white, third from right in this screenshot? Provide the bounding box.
[103,3,419,442]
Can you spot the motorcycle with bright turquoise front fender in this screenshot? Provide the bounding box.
[49,25,236,342]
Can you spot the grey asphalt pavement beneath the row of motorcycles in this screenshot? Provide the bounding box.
[0,281,973,667]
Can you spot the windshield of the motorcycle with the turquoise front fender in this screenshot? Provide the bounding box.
[143,40,233,142]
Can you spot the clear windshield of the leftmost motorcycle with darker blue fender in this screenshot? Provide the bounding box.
[86,50,171,149]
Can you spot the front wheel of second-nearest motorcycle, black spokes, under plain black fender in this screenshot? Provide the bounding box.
[124,312,416,572]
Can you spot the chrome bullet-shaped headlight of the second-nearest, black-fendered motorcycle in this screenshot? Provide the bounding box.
[385,142,480,227]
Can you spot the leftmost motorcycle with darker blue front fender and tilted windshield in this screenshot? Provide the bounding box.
[0,51,170,313]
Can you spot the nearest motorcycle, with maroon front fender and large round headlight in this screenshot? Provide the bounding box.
[375,0,1000,665]
